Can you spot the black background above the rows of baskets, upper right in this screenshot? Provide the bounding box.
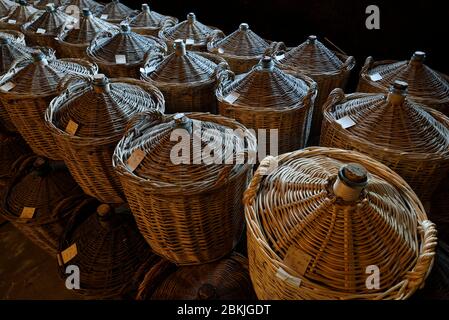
[122,0,449,87]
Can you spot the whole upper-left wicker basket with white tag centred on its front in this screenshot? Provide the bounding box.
[87,24,167,78]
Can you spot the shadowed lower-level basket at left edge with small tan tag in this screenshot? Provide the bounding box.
[1,156,85,255]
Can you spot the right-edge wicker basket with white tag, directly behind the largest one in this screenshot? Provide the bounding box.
[321,81,449,202]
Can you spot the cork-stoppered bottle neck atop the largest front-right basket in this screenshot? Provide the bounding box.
[333,163,368,202]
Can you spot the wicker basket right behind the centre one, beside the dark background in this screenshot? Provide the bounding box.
[268,36,355,136]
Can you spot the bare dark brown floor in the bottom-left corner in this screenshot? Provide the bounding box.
[0,221,80,300]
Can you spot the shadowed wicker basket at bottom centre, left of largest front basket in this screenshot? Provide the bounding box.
[136,253,255,300]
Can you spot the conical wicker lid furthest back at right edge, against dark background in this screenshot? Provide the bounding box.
[362,51,449,100]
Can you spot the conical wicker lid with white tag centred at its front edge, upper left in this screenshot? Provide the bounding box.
[88,24,166,64]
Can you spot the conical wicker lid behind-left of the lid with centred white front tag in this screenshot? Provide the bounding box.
[60,9,120,45]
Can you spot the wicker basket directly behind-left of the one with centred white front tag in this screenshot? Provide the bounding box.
[58,9,120,59]
